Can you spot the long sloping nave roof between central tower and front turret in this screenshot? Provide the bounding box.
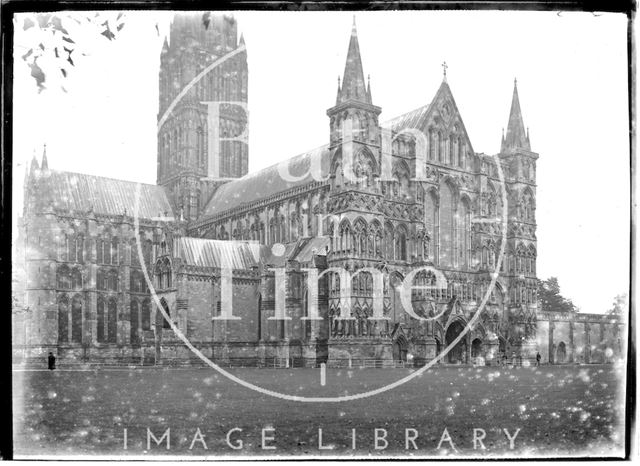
[203,146,329,216]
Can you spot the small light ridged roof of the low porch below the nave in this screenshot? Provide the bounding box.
[173,237,268,270]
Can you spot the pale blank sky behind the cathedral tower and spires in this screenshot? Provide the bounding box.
[13,11,630,313]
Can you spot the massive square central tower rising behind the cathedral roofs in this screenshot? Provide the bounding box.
[157,13,249,221]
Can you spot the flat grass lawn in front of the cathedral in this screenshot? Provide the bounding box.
[13,365,624,458]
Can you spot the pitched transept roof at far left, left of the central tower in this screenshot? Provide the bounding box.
[39,170,173,219]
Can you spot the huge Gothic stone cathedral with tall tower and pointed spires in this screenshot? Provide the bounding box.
[13,13,622,367]
